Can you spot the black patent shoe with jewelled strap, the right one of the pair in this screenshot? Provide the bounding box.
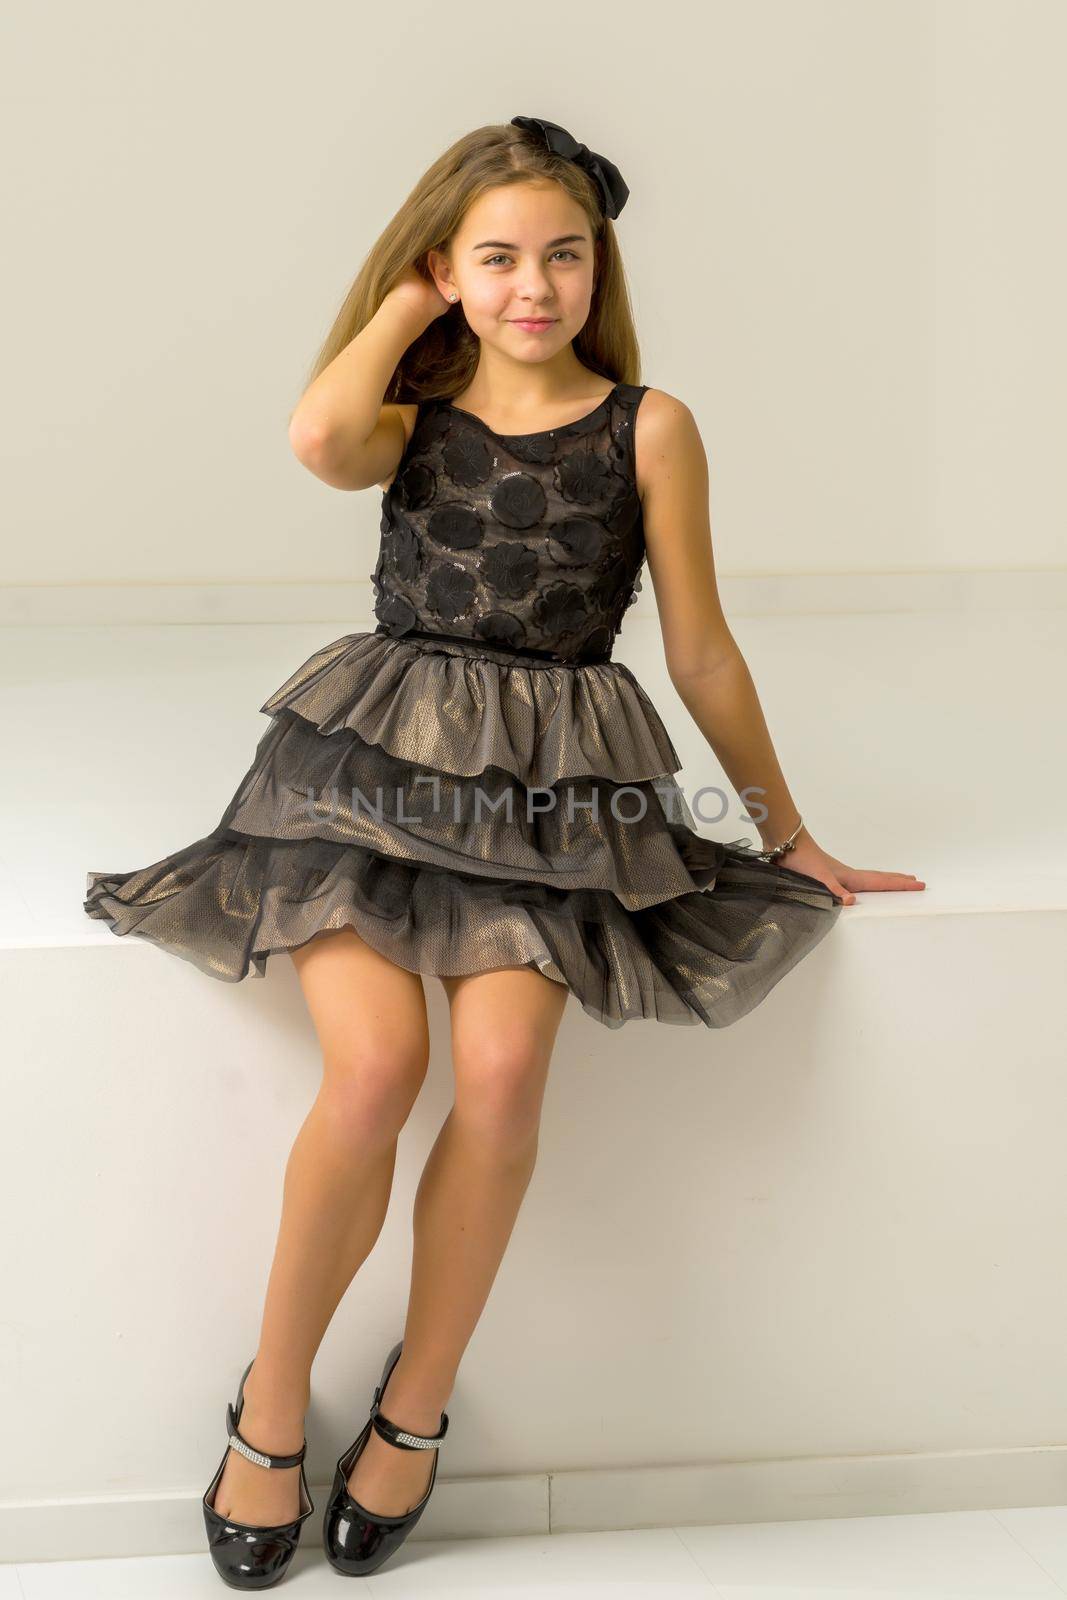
[323,1339,448,1578]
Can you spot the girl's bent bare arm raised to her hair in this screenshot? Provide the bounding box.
[290,267,448,490]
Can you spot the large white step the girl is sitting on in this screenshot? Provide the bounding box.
[0,584,1067,1562]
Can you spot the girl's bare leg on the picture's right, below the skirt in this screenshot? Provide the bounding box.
[349,966,568,1517]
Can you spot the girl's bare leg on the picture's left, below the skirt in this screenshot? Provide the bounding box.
[214,928,430,1526]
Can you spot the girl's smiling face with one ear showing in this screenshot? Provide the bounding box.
[427,179,595,362]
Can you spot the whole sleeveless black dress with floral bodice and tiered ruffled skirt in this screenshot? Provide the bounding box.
[83,384,843,1027]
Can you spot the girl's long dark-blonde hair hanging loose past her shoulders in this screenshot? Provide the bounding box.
[295,123,640,403]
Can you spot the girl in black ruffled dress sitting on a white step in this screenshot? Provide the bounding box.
[85,117,923,1587]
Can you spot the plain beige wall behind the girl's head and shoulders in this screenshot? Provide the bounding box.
[0,0,1067,592]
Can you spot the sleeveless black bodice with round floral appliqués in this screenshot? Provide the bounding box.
[371,384,646,661]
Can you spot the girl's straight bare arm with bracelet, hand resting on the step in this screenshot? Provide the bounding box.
[635,389,926,906]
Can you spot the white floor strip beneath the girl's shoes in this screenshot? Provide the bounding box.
[0,1506,1067,1600]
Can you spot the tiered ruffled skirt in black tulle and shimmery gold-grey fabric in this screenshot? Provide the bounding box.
[85,634,841,1027]
